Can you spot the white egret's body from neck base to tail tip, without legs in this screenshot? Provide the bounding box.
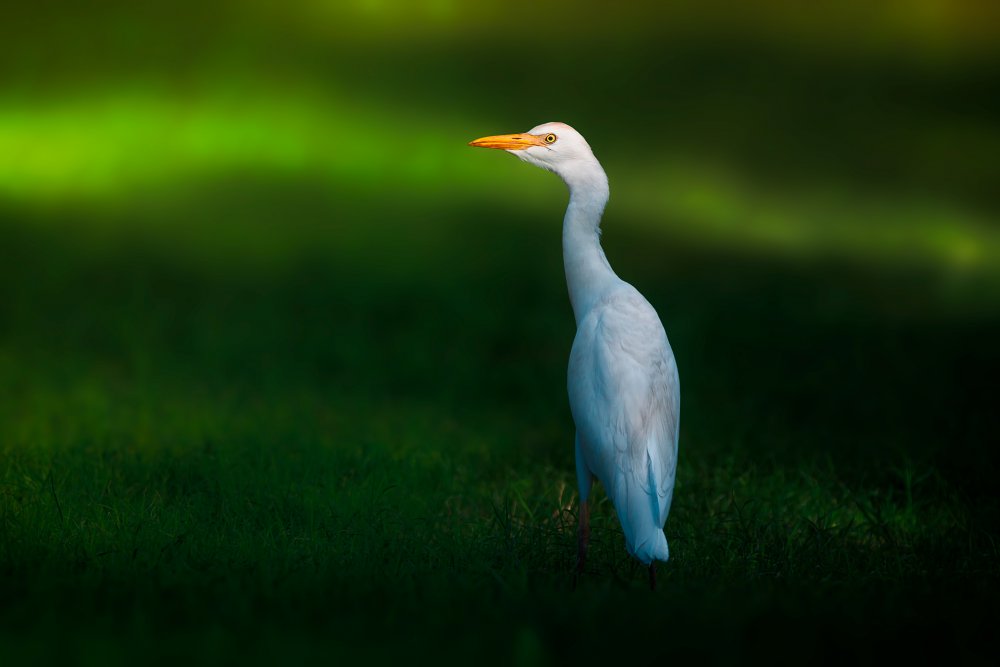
[568,282,680,563]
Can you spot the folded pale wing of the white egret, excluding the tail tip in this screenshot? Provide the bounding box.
[574,286,680,531]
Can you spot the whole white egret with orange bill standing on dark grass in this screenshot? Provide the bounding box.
[470,123,680,587]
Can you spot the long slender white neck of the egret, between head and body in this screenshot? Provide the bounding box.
[563,164,619,325]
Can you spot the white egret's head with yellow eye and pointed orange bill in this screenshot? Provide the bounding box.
[469,123,604,184]
